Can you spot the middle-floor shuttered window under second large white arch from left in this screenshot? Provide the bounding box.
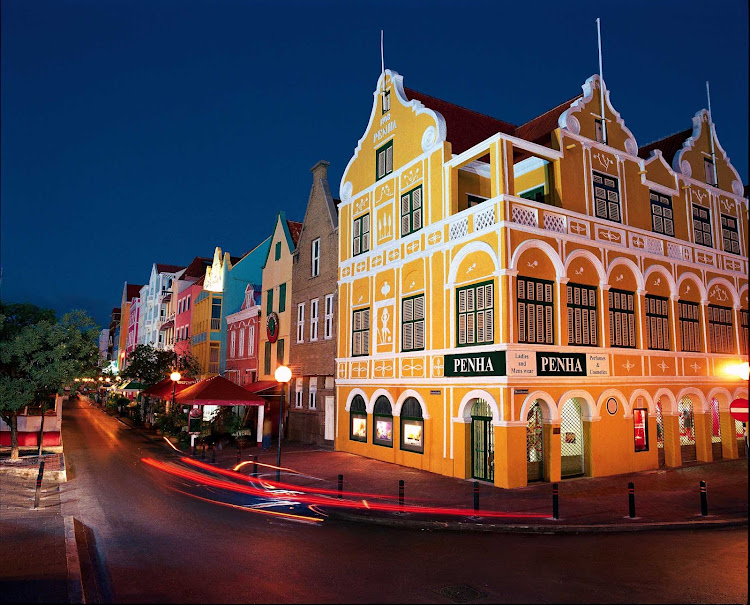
[518,277,555,345]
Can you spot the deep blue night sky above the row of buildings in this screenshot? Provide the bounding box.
[0,0,748,325]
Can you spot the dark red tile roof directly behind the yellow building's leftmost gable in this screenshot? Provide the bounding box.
[404,88,516,154]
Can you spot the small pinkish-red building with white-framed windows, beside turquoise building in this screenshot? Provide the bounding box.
[224,284,261,386]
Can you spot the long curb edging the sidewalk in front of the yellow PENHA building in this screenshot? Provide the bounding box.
[328,507,748,534]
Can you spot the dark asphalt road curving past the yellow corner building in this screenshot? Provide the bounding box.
[63,400,748,603]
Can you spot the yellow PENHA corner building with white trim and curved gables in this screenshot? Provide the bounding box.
[336,70,748,487]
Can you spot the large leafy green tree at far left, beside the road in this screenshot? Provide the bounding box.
[0,303,99,460]
